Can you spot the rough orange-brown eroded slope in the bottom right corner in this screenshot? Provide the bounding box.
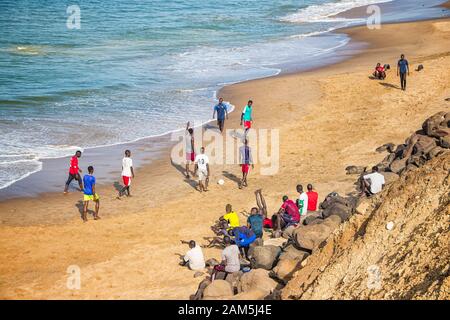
[282,152,450,299]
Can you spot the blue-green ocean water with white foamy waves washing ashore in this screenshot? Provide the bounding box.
[0,0,444,189]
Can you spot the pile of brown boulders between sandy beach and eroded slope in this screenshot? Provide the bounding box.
[192,112,450,299]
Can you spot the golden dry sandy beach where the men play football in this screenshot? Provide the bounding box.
[0,8,450,299]
